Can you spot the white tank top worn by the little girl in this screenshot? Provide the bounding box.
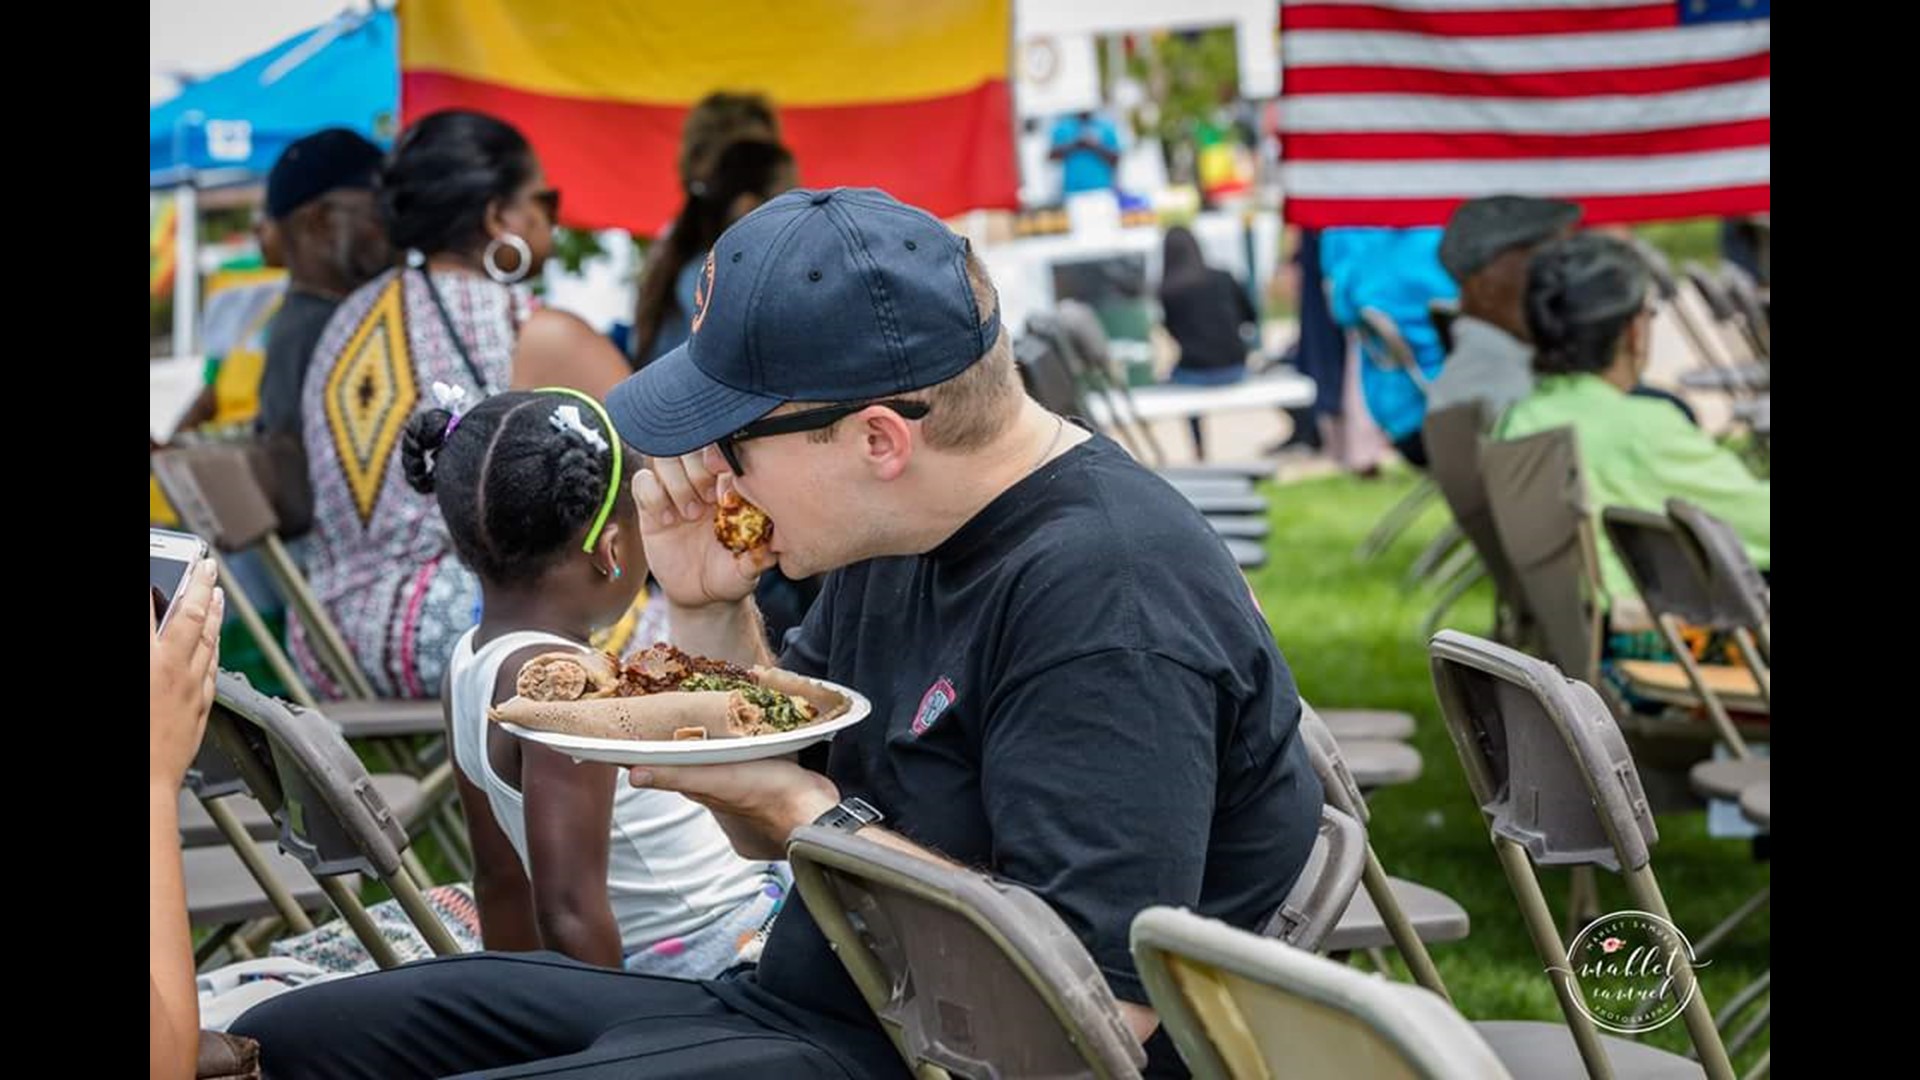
[449,630,768,951]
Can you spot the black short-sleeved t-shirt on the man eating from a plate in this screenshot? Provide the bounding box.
[710,436,1321,1076]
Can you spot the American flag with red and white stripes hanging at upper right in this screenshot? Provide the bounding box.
[1279,0,1772,229]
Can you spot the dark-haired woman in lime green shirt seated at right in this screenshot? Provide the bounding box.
[1498,233,1772,598]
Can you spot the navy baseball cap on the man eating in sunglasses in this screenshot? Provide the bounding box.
[607,188,1000,455]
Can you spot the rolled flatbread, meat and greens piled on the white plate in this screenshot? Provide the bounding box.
[488,642,851,742]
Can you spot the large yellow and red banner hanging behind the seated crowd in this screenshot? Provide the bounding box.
[399,0,1020,234]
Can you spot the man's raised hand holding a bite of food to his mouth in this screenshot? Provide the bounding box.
[634,452,776,607]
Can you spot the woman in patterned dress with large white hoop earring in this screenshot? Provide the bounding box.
[288,111,628,698]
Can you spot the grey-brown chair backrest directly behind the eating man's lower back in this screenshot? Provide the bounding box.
[787,826,1146,1078]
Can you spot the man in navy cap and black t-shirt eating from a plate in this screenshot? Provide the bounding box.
[232,188,1323,1078]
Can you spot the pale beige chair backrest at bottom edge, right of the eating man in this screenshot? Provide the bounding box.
[1131,907,1507,1080]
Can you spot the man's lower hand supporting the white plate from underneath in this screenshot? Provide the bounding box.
[628,759,839,859]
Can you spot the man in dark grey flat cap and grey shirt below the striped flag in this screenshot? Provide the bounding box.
[1427,194,1580,417]
